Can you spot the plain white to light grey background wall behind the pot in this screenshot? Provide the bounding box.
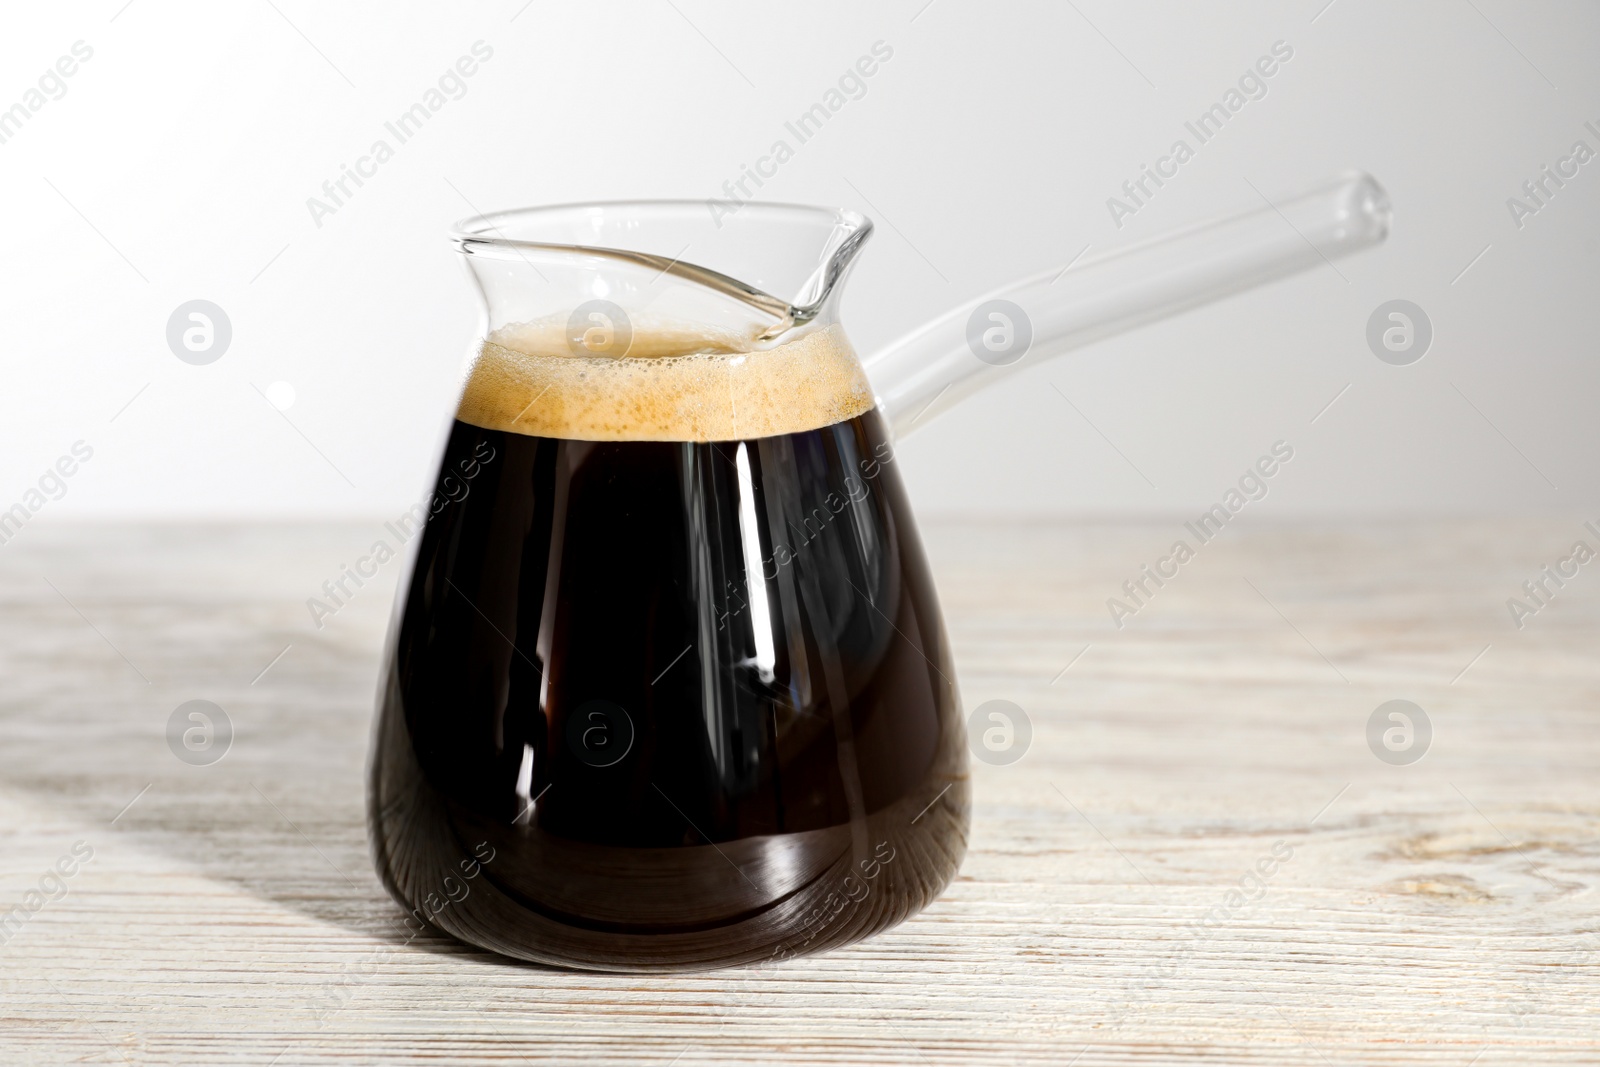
[0,0,1600,522]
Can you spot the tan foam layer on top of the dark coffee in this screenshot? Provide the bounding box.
[456,317,874,442]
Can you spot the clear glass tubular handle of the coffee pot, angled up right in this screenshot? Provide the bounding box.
[866,173,1390,437]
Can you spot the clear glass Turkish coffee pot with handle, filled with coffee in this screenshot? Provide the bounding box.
[370,176,1389,971]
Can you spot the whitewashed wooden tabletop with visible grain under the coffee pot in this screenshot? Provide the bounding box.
[0,520,1600,1067]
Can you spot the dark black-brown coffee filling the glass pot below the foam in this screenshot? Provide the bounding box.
[370,411,968,969]
